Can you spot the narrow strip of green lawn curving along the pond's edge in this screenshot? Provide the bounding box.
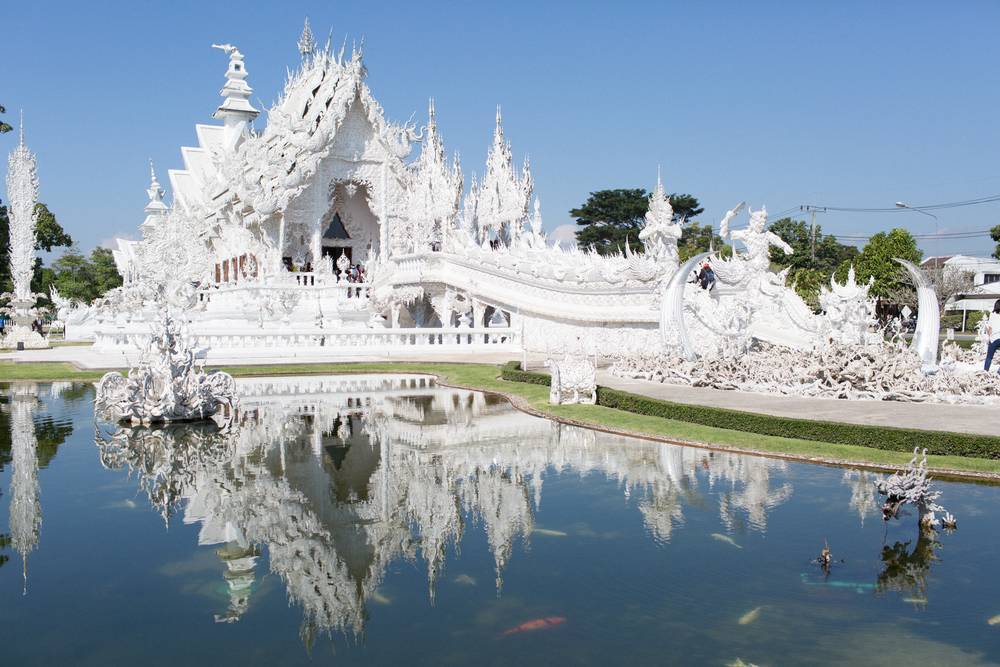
[0,362,1000,475]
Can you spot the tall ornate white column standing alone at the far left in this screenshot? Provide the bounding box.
[2,116,49,349]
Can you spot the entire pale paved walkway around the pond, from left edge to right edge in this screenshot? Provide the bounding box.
[7,346,1000,445]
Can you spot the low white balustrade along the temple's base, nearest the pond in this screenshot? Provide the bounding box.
[94,327,518,356]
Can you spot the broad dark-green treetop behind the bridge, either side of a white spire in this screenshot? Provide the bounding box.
[569,188,704,255]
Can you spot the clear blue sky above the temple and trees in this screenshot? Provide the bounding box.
[0,0,1000,254]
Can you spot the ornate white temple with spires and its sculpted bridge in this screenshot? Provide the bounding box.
[59,20,892,368]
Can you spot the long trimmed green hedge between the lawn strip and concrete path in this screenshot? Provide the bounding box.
[500,362,1000,459]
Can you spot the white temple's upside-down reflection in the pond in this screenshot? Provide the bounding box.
[97,375,792,636]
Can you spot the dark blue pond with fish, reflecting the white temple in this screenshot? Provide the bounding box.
[0,375,1000,665]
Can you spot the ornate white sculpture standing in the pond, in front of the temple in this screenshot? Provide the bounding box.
[95,313,236,424]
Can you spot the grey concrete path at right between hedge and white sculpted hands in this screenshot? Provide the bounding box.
[597,371,1000,438]
